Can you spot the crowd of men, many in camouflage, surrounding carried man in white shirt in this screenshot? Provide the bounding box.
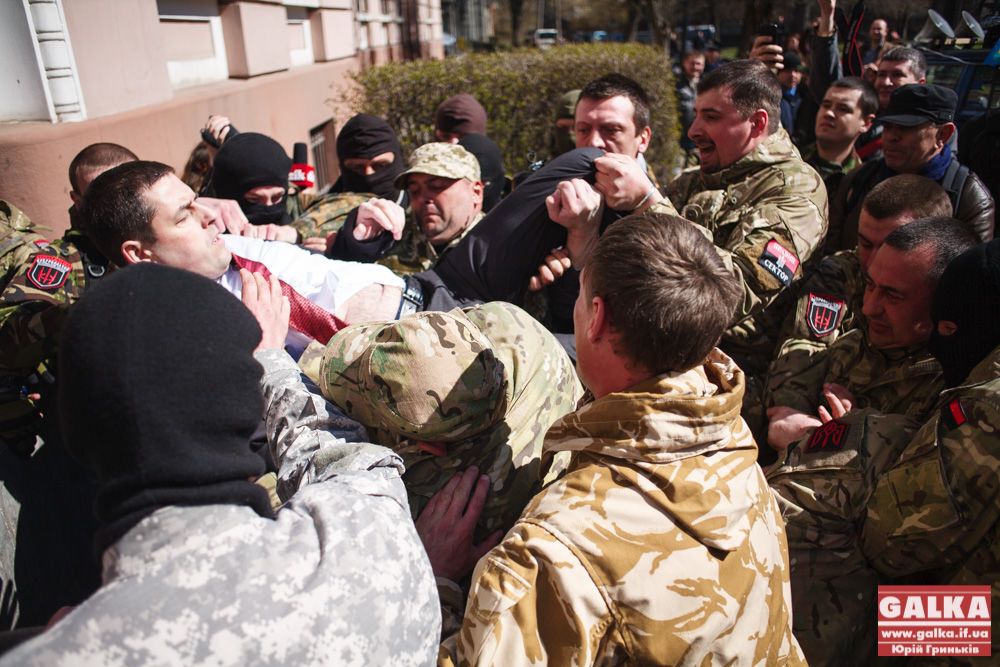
[0,13,1000,665]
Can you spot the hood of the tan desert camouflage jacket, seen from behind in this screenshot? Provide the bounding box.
[545,350,766,551]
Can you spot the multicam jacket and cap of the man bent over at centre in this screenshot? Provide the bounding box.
[320,302,583,539]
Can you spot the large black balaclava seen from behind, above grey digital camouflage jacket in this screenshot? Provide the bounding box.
[58,262,273,552]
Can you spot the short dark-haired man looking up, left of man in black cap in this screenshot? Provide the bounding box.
[802,76,878,193]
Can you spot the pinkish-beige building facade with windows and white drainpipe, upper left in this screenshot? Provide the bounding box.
[0,0,443,236]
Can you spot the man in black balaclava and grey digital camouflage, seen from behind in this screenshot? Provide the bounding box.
[0,263,441,667]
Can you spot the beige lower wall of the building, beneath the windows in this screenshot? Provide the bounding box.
[0,58,357,237]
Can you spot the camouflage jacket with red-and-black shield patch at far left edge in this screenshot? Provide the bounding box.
[0,229,110,447]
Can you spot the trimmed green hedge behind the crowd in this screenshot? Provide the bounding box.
[341,44,679,182]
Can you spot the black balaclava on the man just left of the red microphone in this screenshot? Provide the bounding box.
[212,132,292,225]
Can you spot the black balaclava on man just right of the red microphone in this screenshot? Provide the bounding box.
[333,113,406,201]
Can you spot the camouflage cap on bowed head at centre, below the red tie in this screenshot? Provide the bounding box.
[320,309,507,442]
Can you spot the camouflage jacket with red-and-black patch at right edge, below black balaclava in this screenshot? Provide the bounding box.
[862,348,1000,656]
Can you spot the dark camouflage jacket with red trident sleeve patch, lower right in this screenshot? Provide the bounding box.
[766,409,919,667]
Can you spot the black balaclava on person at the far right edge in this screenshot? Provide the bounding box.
[928,239,1000,387]
